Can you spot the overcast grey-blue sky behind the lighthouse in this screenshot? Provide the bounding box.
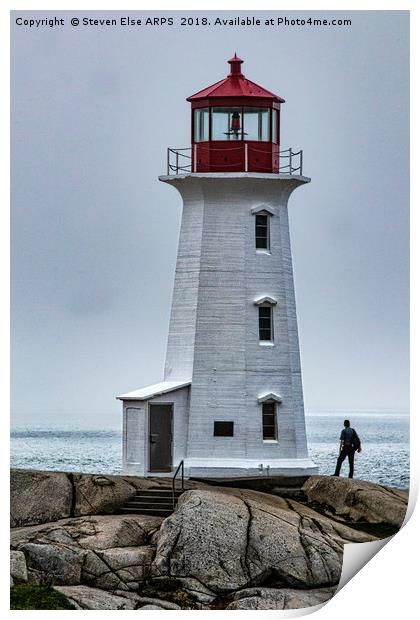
[12,11,409,427]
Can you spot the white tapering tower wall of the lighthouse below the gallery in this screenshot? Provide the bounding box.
[161,173,314,475]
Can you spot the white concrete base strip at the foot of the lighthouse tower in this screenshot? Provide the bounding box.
[184,458,318,478]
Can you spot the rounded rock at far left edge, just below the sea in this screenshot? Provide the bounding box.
[10,469,73,527]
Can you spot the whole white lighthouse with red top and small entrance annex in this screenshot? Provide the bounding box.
[118,54,317,477]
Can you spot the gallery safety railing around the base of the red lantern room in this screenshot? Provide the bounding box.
[167,142,303,175]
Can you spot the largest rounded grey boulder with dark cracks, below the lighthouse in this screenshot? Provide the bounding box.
[152,489,374,593]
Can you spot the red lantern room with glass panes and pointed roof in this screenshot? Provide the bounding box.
[187,54,284,173]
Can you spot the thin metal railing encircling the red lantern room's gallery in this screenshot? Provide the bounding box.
[167,142,303,175]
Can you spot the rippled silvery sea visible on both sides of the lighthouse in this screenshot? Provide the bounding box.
[11,413,409,488]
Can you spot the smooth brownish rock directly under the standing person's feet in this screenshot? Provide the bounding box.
[302,476,408,527]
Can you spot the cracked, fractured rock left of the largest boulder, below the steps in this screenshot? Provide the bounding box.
[11,515,162,591]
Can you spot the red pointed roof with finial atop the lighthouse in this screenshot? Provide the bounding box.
[187,54,285,103]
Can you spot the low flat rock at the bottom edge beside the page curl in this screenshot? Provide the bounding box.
[226,588,336,610]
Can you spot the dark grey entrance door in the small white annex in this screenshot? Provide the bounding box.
[149,405,172,472]
